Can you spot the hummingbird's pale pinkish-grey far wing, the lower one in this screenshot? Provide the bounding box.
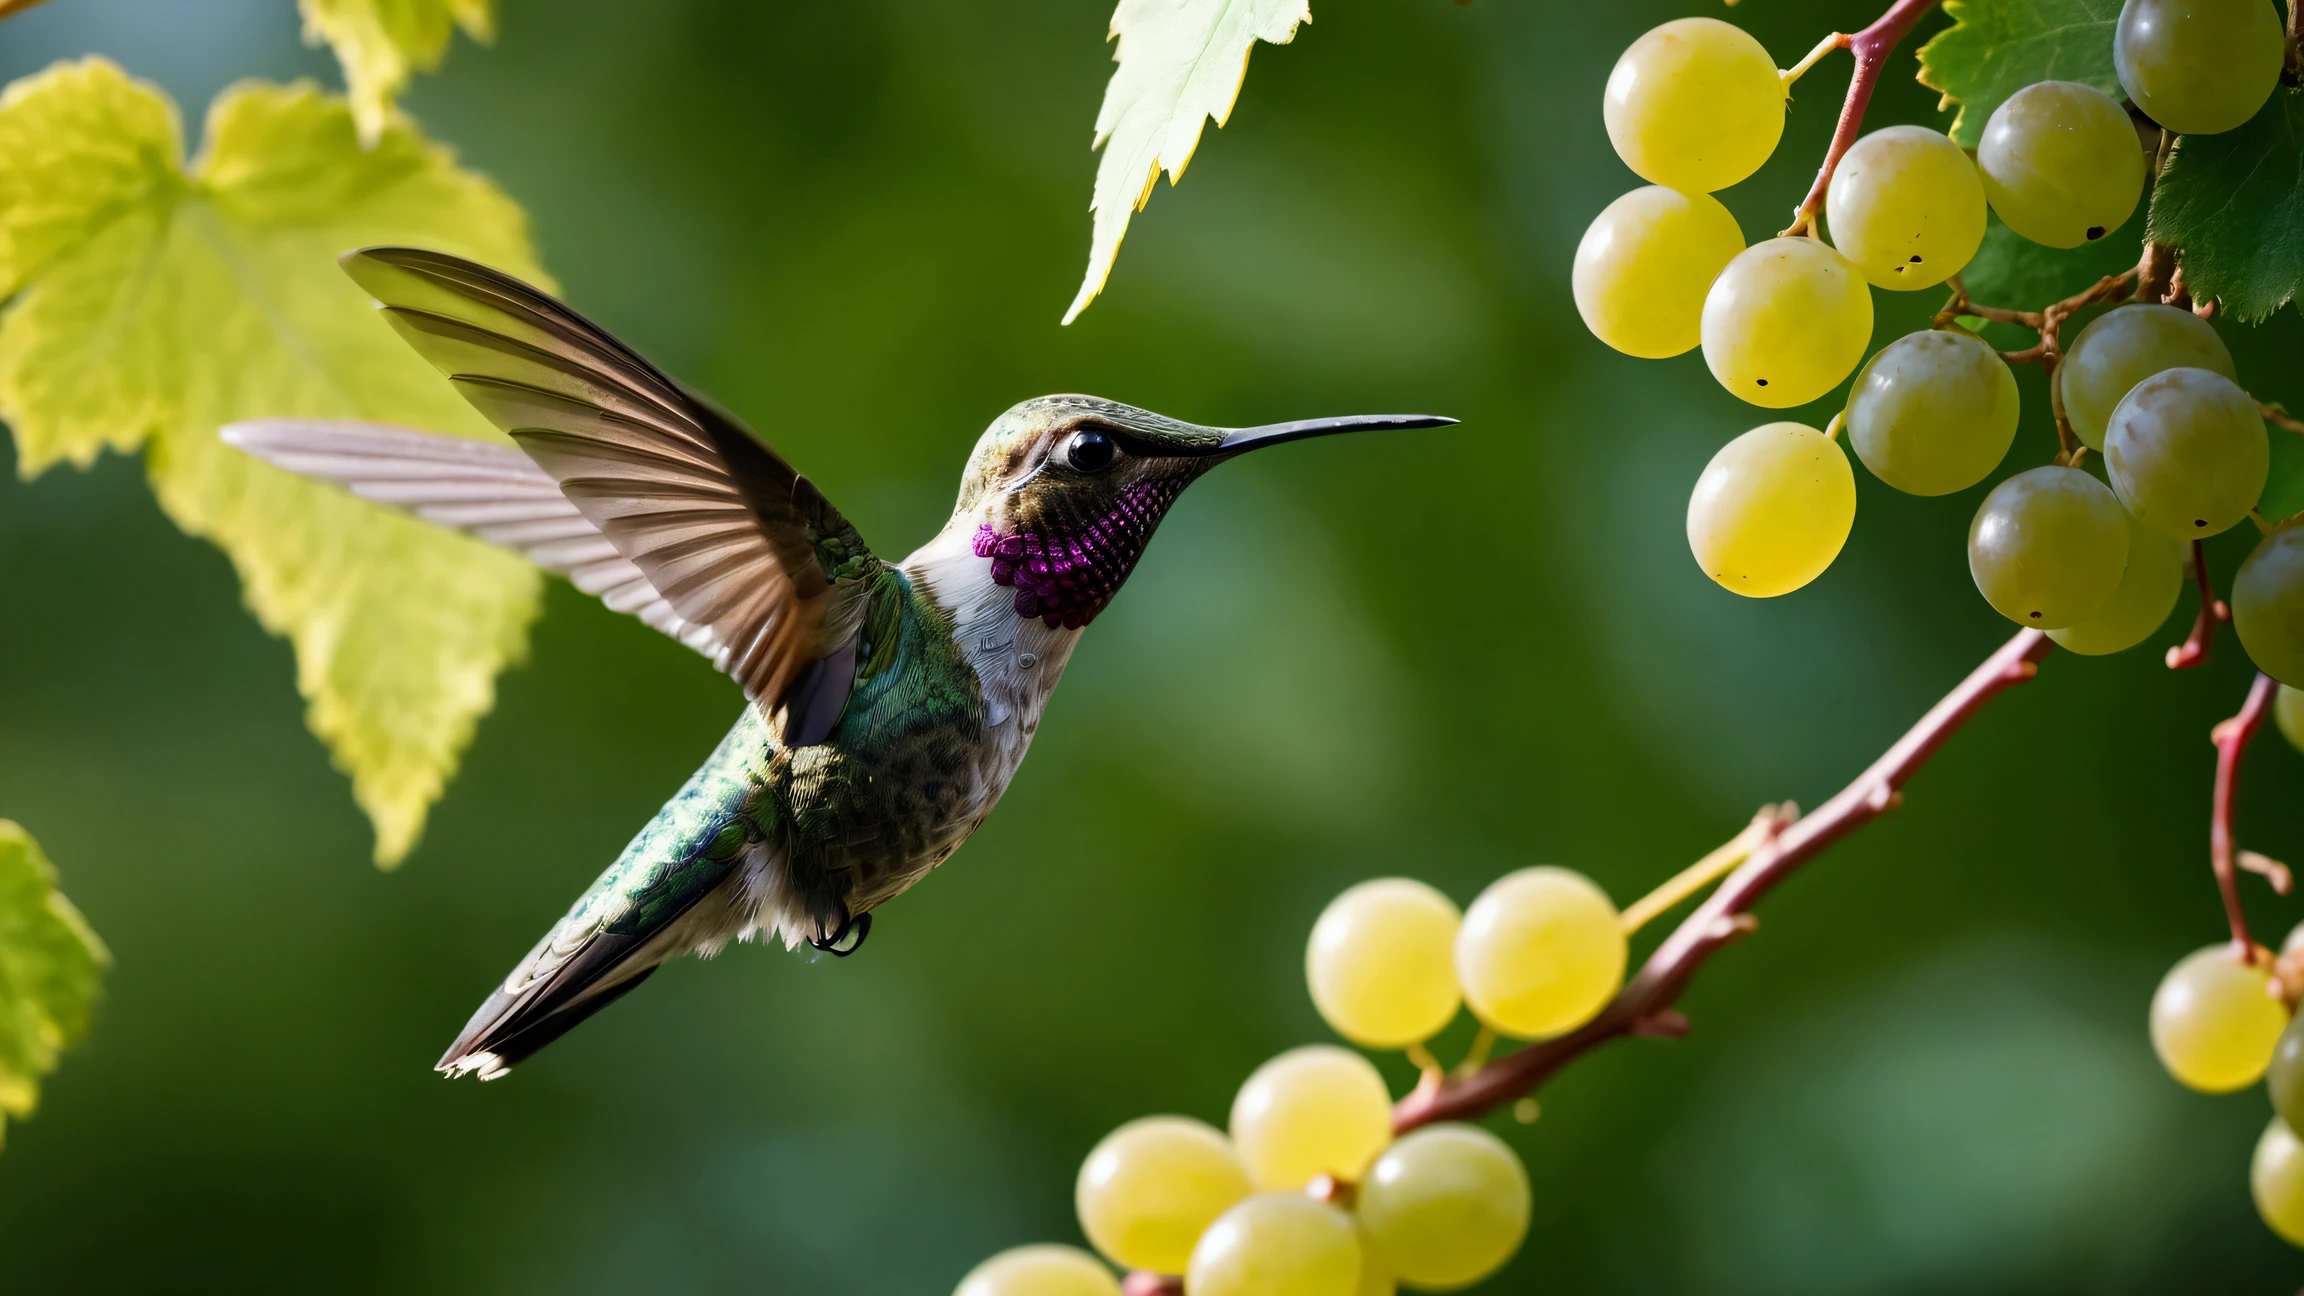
[223,417,728,662]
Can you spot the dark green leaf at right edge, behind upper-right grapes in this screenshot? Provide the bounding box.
[2145,90,2304,323]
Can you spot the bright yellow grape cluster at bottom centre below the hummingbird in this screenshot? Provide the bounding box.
[958,867,1629,1296]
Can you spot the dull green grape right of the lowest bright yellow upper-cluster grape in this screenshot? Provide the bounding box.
[1848,330,2016,496]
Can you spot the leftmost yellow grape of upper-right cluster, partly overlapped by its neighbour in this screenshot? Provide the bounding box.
[1569,184,1744,360]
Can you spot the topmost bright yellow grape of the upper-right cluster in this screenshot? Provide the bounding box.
[1601,18,1786,194]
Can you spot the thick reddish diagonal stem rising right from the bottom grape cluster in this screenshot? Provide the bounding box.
[1382,630,2055,1129]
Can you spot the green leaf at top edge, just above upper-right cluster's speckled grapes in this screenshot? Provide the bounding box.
[1919,0,2120,148]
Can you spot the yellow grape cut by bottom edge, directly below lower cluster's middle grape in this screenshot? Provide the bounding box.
[1184,1192,1359,1296]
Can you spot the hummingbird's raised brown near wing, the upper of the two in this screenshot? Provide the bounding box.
[329,247,887,745]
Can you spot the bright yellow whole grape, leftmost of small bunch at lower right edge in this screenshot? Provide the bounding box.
[2152,945,2288,1093]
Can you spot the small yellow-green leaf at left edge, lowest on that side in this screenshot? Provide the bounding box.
[0,819,111,1135]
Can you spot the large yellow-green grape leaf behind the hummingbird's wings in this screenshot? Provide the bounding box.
[0,58,546,865]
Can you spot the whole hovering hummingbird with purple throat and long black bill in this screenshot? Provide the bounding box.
[221,247,1456,1079]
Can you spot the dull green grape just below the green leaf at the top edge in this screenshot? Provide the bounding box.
[1977,81,2145,247]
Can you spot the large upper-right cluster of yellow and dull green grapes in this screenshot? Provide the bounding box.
[1574,0,2304,680]
